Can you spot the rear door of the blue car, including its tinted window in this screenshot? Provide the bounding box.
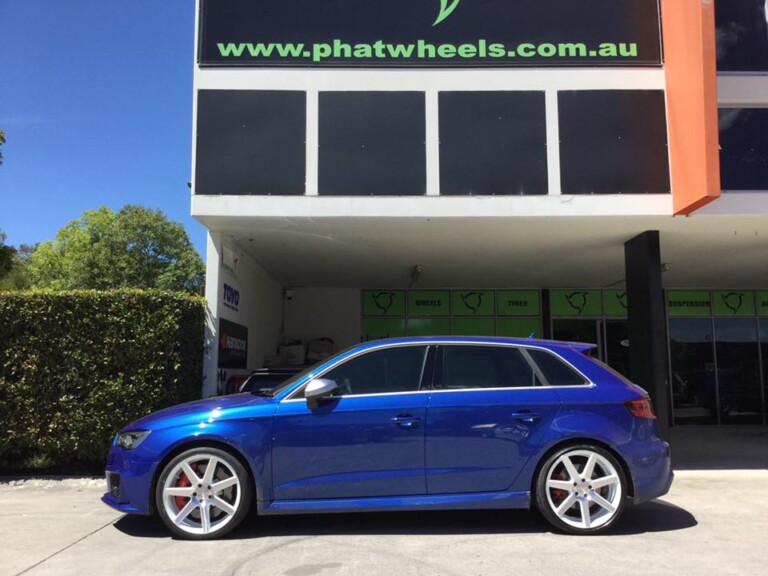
[426,344,560,494]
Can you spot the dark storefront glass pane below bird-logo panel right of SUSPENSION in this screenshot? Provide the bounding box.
[715,318,763,424]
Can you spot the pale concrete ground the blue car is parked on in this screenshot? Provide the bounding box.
[0,427,768,576]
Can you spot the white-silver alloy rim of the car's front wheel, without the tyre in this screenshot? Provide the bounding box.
[162,452,243,535]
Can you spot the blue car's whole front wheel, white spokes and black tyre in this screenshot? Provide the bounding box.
[155,447,252,540]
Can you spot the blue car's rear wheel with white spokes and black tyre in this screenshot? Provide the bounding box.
[536,444,627,534]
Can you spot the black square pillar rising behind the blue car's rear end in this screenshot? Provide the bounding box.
[624,230,671,440]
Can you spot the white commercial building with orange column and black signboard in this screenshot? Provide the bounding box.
[192,0,768,432]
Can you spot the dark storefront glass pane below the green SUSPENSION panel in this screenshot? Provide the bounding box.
[669,318,717,424]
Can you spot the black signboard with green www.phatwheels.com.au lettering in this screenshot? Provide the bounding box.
[199,0,661,67]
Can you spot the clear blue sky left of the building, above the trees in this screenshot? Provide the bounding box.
[0,0,205,258]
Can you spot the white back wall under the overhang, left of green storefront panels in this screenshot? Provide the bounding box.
[285,288,361,350]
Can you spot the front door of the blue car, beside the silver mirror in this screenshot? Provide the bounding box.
[272,345,429,500]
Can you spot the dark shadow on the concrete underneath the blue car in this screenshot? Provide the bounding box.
[114,500,697,540]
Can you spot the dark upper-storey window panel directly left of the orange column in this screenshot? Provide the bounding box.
[558,90,671,194]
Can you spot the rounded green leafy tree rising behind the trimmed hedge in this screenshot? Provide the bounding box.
[29,205,205,293]
